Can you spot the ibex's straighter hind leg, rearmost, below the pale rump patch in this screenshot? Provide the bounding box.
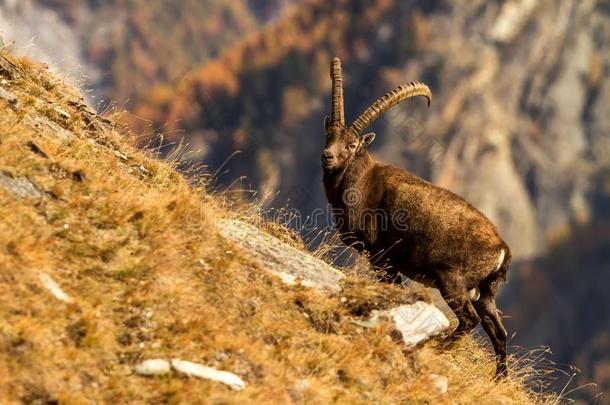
[474,273,508,378]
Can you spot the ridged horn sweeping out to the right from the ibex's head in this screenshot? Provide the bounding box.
[349,82,432,135]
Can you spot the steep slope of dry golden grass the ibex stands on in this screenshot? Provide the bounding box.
[0,51,556,404]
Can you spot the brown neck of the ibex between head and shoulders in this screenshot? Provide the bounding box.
[323,151,375,208]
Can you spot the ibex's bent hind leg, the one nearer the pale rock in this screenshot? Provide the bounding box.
[437,271,480,343]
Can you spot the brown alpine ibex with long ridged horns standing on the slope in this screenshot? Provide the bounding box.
[322,58,511,376]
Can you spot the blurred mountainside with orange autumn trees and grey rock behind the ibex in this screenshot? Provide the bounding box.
[0,0,610,403]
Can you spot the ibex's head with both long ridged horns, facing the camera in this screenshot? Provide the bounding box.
[322,58,432,172]
